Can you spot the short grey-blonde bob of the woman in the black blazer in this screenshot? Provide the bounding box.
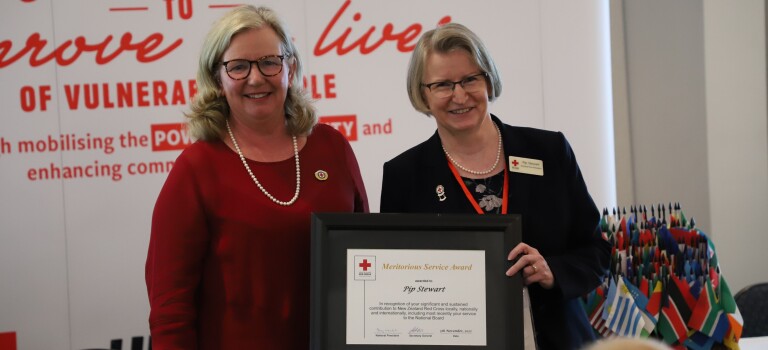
[407,23,501,115]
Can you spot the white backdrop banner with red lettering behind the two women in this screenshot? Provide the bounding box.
[0,0,615,350]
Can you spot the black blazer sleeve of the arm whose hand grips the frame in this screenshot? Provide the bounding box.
[547,133,611,299]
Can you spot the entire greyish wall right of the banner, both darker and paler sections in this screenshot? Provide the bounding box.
[611,0,768,292]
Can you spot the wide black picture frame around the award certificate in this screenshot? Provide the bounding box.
[310,213,524,350]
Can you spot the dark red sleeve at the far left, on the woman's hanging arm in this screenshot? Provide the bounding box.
[145,154,208,350]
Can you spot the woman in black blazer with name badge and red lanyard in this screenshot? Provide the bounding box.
[381,23,610,350]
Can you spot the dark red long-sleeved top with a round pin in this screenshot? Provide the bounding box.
[145,124,368,350]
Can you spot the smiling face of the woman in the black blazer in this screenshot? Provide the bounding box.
[422,49,490,135]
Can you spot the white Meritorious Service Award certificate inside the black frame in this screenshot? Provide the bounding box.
[346,249,487,346]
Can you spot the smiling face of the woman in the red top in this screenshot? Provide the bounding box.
[219,26,294,127]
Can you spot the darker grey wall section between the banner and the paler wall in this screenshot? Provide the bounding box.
[617,0,710,232]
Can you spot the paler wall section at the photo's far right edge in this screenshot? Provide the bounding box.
[704,0,768,292]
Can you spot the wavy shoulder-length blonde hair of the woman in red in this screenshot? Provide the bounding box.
[185,5,317,140]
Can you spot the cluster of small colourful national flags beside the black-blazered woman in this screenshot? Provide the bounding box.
[583,203,744,349]
